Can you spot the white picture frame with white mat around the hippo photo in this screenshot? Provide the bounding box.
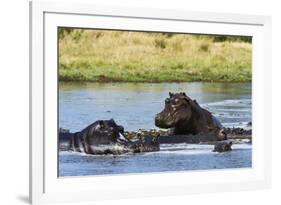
[30,1,271,204]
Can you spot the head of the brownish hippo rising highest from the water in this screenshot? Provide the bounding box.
[155,92,196,129]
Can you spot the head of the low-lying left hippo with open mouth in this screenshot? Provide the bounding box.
[88,119,128,144]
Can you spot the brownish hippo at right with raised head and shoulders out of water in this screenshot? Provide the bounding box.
[155,92,227,140]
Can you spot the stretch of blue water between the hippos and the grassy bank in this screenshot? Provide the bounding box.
[59,82,251,131]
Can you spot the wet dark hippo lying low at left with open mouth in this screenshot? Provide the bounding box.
[60,119,160,154]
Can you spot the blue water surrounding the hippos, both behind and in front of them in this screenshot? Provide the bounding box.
[59,82,252,176]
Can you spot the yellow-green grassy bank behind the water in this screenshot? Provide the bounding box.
[59,29,252,82]
